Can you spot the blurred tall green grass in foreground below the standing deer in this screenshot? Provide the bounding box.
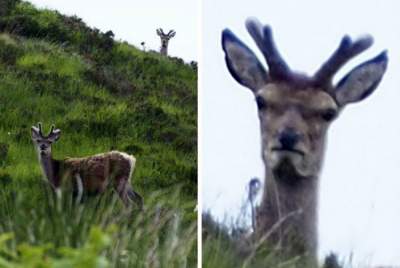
[0,182,197,267]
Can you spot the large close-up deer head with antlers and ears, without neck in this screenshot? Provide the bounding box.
[222,19,388,180]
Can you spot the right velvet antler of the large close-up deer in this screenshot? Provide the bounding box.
[314,35,373,86]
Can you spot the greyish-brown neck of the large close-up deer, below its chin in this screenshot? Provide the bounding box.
[258,158,318,257]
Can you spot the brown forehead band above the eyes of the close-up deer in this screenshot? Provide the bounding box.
[257,84,338,110]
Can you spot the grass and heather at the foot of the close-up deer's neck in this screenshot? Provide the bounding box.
[202,212,344,268]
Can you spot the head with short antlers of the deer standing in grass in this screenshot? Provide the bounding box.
[31,123,61,156]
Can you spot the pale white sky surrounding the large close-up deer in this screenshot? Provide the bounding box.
[203,0,400,267]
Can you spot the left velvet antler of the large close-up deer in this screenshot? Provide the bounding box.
[246,18,291,79]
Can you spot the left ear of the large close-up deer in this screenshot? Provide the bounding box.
[222,29,267,91]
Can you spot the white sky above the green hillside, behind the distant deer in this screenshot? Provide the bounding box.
[29,0,199,62]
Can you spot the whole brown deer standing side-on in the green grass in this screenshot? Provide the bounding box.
[31,123,143,209]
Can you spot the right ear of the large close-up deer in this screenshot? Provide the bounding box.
[335,51,388,106]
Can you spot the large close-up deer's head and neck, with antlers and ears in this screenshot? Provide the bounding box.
[222,19,388,260]
